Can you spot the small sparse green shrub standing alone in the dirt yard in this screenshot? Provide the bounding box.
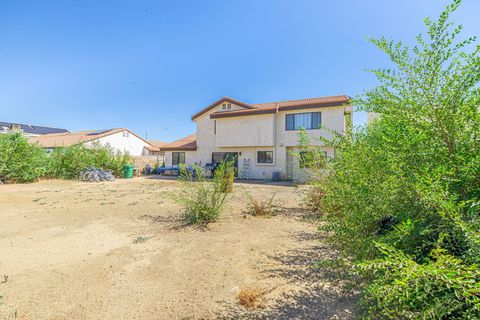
[172,162,233,225]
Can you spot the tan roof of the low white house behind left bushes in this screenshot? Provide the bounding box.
[29,128,151,148]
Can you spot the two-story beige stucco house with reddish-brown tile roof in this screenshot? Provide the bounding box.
[160,95,352,180]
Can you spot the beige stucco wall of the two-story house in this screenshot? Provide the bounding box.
[189,104,345,181]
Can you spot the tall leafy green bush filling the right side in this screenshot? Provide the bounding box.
[309,1,480,319]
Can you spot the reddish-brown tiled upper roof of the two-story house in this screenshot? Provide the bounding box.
[192,95,350,120]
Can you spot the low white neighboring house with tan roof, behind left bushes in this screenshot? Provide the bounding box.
[29,128,160,156]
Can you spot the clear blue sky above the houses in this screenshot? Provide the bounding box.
[0,0,480,141]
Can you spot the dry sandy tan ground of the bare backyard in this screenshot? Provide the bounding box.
[0,178,354,319]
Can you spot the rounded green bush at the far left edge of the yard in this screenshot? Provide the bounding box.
[0,133,48,182]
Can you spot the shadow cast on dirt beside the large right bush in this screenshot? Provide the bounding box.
[218,232,357,320]
